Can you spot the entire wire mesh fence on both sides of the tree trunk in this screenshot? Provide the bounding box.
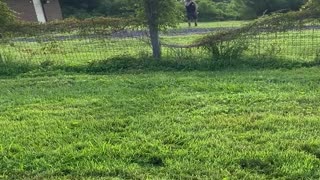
[0,20,320,64]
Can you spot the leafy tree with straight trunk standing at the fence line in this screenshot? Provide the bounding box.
[135,0,181,59]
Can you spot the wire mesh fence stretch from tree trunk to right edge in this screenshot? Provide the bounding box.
[164,23,320,61]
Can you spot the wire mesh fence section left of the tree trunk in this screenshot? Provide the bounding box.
[0,30,150,64]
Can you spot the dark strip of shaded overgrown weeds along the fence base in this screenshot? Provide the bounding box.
[0,57,320,77]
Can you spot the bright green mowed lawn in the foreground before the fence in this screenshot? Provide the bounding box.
[0,67,320,179]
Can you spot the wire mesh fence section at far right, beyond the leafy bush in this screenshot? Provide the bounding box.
[248,26,320,61]
